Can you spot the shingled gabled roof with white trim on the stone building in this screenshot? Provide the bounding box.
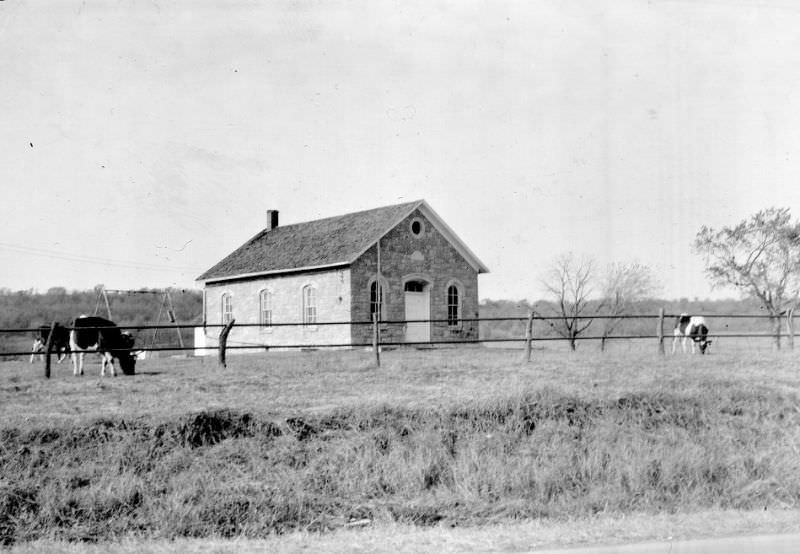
[197,200,488,282]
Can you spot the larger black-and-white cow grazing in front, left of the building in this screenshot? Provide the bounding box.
[69,315,136,377]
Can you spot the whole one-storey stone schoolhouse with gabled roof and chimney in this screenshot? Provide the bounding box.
[195,200,488,354]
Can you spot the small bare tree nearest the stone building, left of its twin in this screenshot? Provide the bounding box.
[542,253,594,350]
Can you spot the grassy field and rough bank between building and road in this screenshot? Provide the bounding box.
[0,349,800,544]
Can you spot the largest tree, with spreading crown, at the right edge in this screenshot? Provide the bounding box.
[694,208,800,349]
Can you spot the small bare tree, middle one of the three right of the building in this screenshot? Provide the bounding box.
[598,262,658,351]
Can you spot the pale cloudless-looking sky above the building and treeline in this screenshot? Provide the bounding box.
[0,0,800,299]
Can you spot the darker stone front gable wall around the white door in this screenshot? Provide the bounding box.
[350,210,478,343]
